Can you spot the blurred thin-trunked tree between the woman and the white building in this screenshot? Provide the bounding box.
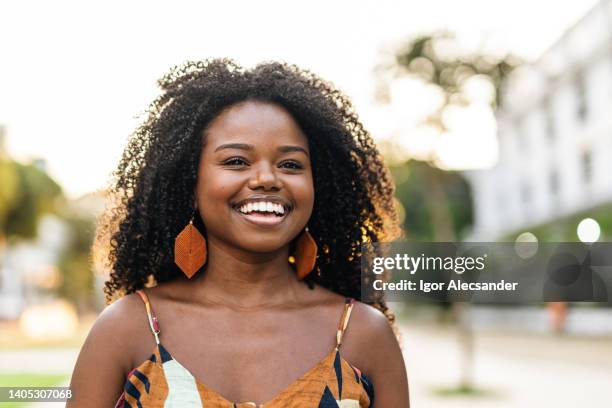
[377,32,521,393]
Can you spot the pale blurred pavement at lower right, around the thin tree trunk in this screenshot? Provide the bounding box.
[400,324,612,408]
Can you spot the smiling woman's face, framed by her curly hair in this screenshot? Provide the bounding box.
[196,101,314,252]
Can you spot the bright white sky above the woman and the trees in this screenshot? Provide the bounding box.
[0,0,596,198]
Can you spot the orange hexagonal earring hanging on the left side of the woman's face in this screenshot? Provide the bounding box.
[174,211,207,279]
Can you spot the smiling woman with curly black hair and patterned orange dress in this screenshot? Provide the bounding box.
[68,60,408,408]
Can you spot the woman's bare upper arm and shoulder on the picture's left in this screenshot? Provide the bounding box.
[67,294,152,407]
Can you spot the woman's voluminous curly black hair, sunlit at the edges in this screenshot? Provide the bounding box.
[96,59,400,321]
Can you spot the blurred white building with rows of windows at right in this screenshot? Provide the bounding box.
[467,0,612,240]
